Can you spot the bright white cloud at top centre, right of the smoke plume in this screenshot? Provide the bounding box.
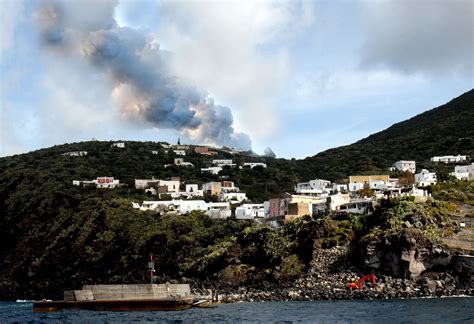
[155,1,314,140]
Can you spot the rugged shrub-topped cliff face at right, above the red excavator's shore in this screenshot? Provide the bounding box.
[355,201,474,288]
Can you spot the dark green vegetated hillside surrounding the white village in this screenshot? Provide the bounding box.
[0,90,474,298]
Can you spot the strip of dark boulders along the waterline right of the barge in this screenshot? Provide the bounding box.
[193,246,474,303]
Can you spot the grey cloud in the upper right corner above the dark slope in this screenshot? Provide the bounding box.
[361,0,474,79]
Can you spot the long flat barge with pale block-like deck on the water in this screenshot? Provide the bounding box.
[33,284,194,312]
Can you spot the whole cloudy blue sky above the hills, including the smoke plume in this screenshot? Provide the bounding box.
[0,0,474,158]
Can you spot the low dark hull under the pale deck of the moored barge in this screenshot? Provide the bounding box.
[33,296,193,312]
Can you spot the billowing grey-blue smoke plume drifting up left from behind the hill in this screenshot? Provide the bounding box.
[35,0,251,149]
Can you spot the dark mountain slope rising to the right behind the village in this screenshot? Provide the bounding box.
[297,90,474,180]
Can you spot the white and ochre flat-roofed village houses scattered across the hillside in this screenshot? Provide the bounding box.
[67,142,474,227]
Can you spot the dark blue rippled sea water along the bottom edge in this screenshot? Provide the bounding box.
[0,297,474,324]
